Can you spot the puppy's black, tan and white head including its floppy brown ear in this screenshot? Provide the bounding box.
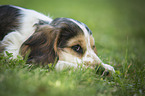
[20,18,109,70]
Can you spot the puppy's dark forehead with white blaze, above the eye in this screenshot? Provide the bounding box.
[50,18,92,49]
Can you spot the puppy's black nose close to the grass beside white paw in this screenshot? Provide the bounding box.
[96,65,110,76]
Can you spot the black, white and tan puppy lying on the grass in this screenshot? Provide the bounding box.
[0,5,115,72]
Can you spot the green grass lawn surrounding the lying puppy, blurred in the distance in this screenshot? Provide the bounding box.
[0,0,145,96]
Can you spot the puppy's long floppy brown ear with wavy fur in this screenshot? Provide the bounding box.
[20,25,59,64]
